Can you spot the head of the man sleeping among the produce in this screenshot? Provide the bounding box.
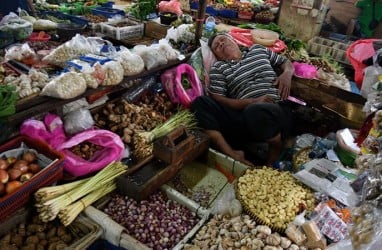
[208,33,241,61]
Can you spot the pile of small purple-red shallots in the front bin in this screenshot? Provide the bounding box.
[103,192,199,250]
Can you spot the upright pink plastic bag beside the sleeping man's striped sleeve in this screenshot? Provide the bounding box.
[160,63,203,108]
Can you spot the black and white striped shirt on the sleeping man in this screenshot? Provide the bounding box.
[208,44,287,101]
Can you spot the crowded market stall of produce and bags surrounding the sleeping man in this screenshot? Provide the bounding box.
[0,0,382,250]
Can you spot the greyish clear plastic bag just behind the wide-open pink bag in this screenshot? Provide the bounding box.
[64,108,94,135]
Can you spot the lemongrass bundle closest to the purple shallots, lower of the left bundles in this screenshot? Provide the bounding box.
[58,181,117,226]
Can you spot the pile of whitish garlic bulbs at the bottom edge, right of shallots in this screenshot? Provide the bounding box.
[184,215,300,250]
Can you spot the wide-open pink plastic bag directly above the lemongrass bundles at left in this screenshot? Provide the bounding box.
[57,129,125,176]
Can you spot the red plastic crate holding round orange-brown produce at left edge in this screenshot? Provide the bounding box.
[0,136,64,221]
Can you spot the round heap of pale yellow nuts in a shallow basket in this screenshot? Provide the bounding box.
[237,167,315,229]
